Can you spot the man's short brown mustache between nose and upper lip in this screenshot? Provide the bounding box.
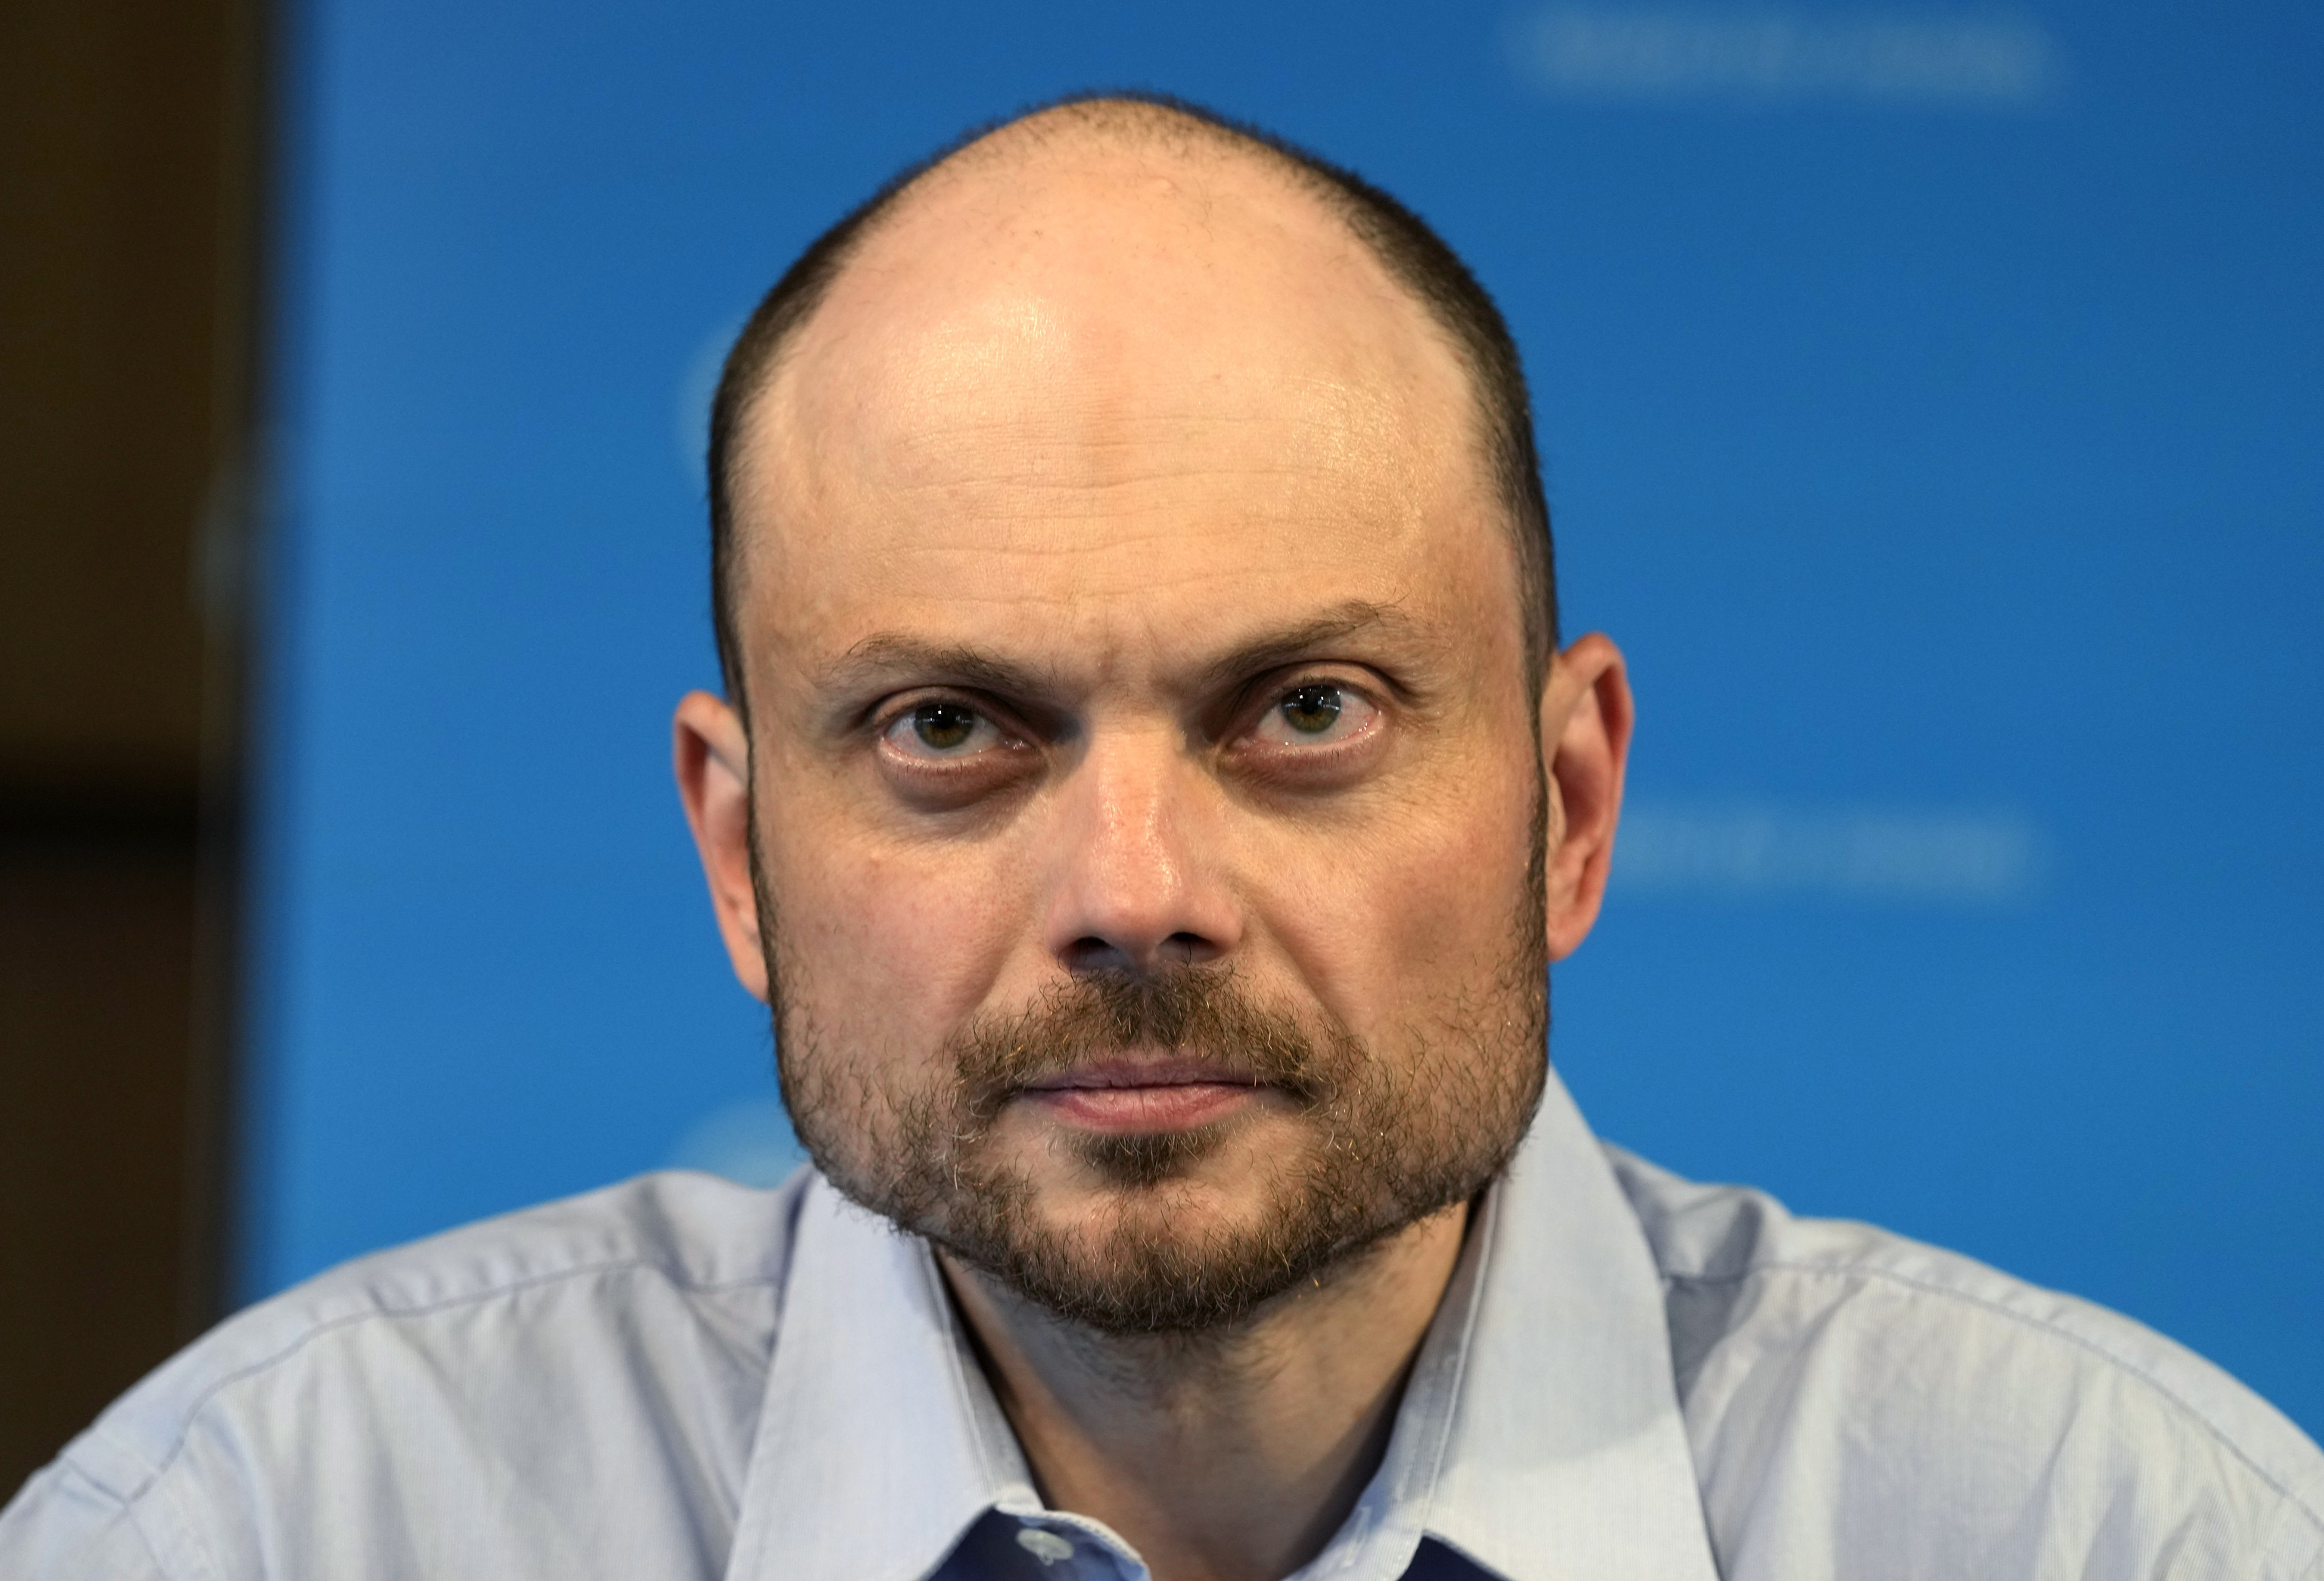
[950,968,1359,1118]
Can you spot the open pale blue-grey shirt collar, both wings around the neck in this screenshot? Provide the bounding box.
[728,1072,1717,1581]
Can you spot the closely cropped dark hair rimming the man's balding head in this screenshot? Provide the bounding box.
[709,93,1557,716]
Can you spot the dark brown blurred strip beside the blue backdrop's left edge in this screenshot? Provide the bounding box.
[0,0,269,1499]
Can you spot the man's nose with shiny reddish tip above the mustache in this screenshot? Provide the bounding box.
[1045,732,1241,974]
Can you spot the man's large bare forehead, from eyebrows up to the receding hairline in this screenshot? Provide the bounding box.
[735,149,1515,688]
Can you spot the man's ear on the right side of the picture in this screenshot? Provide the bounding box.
[1541,632,1632,960]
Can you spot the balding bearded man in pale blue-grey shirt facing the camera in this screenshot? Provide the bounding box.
[0,100,2324,1581]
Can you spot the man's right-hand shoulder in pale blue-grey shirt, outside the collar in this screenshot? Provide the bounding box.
[1608,1148,2324,1576]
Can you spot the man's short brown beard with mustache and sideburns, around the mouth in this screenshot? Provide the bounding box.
[750,785,1548,1337]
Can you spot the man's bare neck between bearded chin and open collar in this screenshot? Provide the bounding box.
[939,1207,1466,1581]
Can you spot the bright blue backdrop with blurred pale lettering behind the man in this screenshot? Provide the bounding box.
[241,0,2324,1432]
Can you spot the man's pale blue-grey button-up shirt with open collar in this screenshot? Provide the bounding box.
[14,1079,2324,1581]
